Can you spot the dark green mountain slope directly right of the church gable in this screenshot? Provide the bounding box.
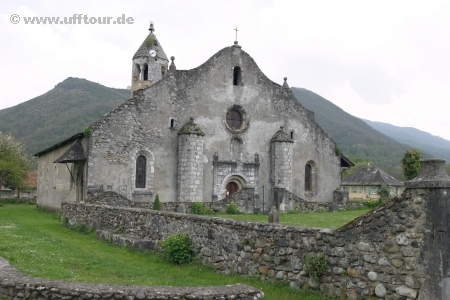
[291,87,410,173]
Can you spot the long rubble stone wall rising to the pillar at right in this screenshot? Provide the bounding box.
[62,160,450,300]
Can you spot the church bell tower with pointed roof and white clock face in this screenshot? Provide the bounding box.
[131,22,169,96]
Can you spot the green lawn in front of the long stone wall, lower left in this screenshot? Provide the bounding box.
[0,204,330,300]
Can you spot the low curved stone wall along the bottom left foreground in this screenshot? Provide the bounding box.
[0,257,264,300]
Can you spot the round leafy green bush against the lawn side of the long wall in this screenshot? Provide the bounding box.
[159,233,194,265]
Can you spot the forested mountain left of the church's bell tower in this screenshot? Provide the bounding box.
[0,77,130,154]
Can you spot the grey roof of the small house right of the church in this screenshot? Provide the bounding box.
[341,167,404,186]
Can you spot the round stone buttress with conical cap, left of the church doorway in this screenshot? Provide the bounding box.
[177,117,205,202]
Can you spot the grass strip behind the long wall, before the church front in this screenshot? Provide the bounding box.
[214,208,370,229]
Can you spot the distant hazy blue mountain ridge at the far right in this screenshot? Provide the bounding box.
[362,119,450,161]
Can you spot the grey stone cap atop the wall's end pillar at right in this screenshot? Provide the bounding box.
[405,158,450,189]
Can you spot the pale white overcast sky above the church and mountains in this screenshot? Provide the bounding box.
[0,0,450,140]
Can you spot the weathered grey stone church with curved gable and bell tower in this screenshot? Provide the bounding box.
[36,24,347,209]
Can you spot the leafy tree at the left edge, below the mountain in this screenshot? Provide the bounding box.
[0,131,32,190]
